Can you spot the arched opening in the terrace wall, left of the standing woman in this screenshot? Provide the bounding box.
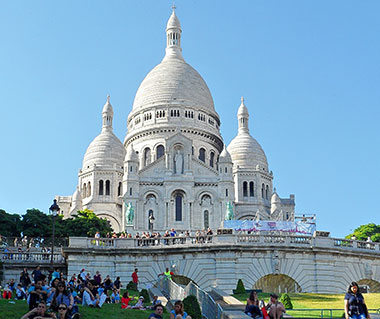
[253,274,302,293]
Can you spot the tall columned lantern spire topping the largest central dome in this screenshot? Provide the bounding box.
[165,4,183,60]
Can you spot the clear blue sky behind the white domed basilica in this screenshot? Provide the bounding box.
[0,0,380,237]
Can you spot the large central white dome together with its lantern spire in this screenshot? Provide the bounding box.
[132,10,217,115]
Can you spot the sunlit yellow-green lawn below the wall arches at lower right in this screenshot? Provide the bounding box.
[233,293,380,318]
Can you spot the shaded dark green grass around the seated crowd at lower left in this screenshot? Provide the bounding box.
[0,299,169,319]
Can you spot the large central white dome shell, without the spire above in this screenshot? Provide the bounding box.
[133,57,215,113]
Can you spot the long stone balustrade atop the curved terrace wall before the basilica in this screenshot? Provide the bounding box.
[69,233,380,253]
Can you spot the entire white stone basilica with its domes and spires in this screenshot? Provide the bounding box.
[56,9,295,232]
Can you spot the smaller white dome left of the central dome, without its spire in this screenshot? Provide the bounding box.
[83,130,125,170]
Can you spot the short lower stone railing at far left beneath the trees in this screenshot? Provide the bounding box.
[0,251,65,264]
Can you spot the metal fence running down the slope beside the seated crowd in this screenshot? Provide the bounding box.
[157,278,222,319]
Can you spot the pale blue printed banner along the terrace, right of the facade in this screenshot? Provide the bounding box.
[224,220,316,236]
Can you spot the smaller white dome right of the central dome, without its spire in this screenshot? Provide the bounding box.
[227,132,268,171]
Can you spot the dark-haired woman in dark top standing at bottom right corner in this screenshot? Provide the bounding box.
[344,281,370,319]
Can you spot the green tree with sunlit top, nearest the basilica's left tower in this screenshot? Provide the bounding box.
[62,209,113,237]
